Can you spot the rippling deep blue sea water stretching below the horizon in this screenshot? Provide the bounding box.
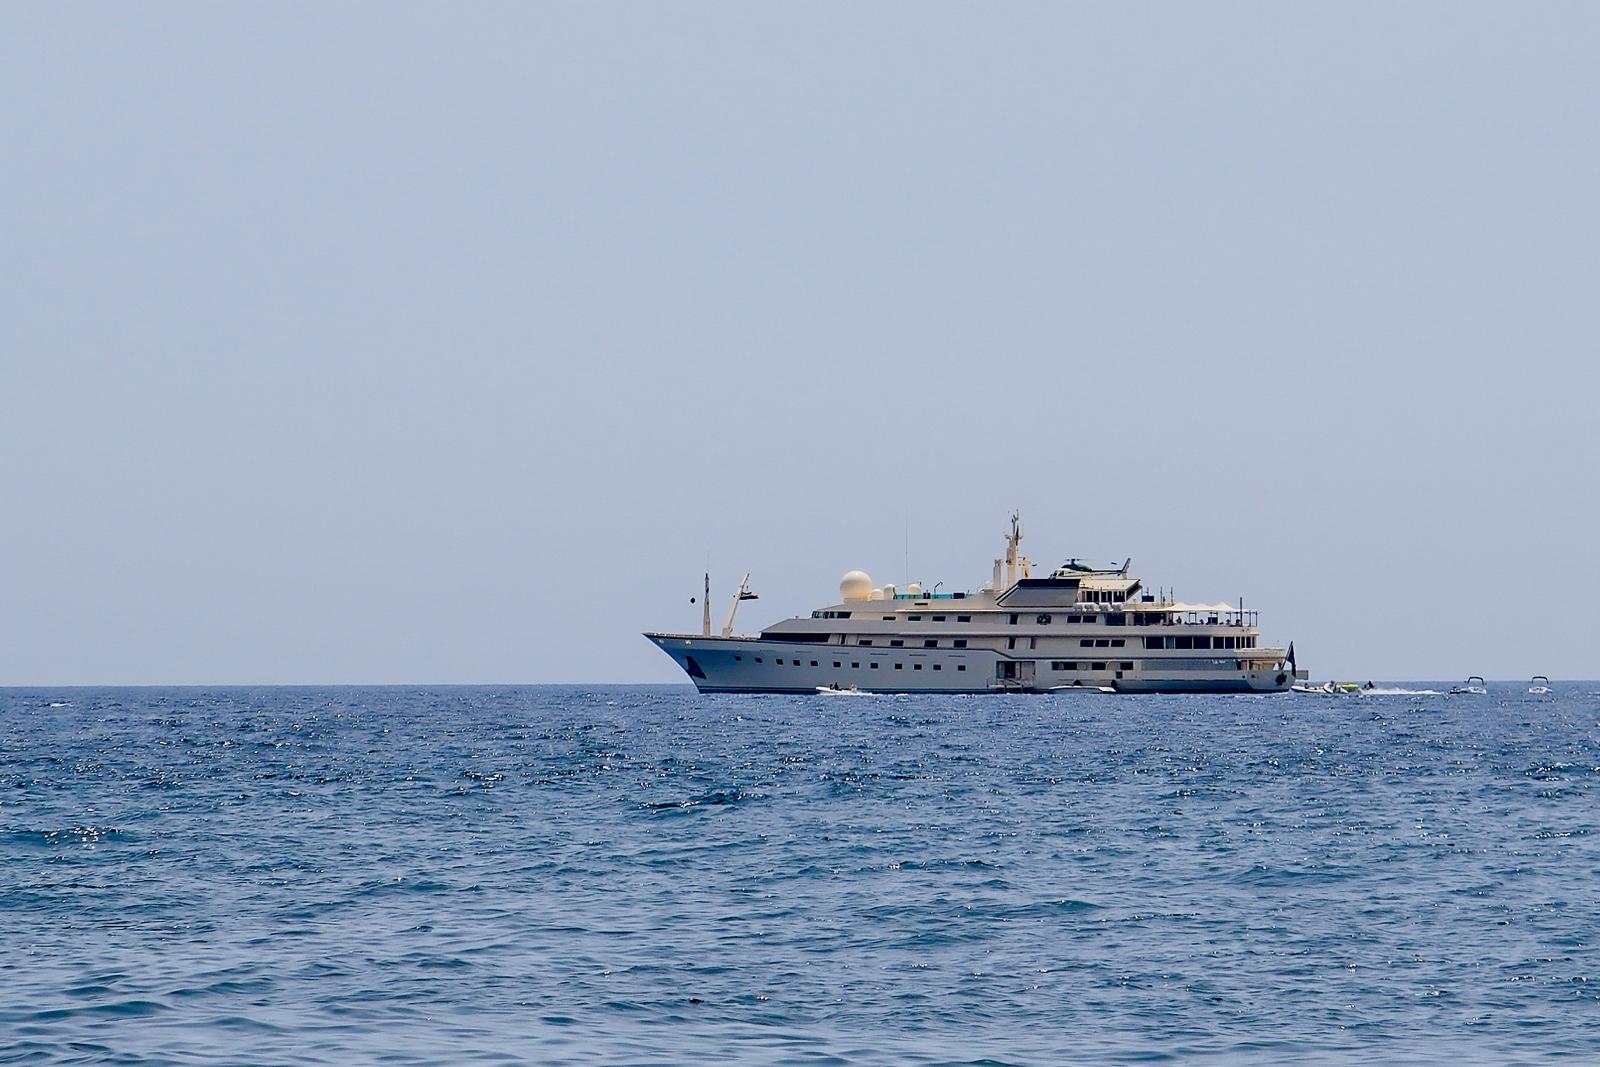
[0,683,1600,1064]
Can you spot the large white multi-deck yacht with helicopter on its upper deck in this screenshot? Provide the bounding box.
[645,515,1306,693]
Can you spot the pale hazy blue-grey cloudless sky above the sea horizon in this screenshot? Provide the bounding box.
[0,2,1600,685]
